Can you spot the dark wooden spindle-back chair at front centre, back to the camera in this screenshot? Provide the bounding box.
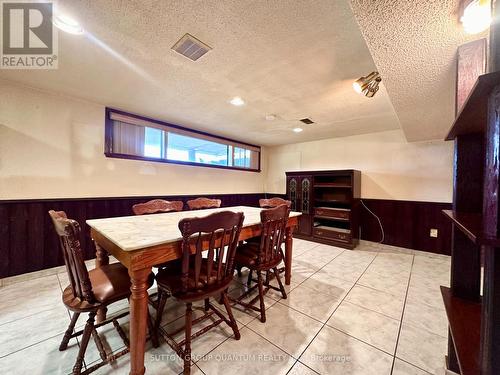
[155,211,244,374]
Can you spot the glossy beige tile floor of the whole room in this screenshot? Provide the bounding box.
[0,240,450,375]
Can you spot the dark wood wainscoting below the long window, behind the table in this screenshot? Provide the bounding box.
[0,193,266,278]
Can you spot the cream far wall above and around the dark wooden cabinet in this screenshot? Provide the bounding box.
[266,130,453,206]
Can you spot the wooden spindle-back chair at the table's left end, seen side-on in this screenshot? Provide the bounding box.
[49,210,158,375]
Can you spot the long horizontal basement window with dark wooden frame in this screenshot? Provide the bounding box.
[105,108,260,172]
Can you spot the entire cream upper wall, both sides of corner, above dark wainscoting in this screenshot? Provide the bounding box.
[0,81,453,202]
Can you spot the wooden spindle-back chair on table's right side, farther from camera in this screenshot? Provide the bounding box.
[232,204,290,323]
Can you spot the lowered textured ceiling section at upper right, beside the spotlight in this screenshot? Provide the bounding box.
[350,0,487,141]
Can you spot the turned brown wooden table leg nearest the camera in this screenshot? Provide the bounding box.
[128,268,151,375]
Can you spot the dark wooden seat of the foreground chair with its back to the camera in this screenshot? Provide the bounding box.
[156,259,232,300]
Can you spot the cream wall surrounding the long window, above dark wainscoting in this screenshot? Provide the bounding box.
[0,80,266,199]
